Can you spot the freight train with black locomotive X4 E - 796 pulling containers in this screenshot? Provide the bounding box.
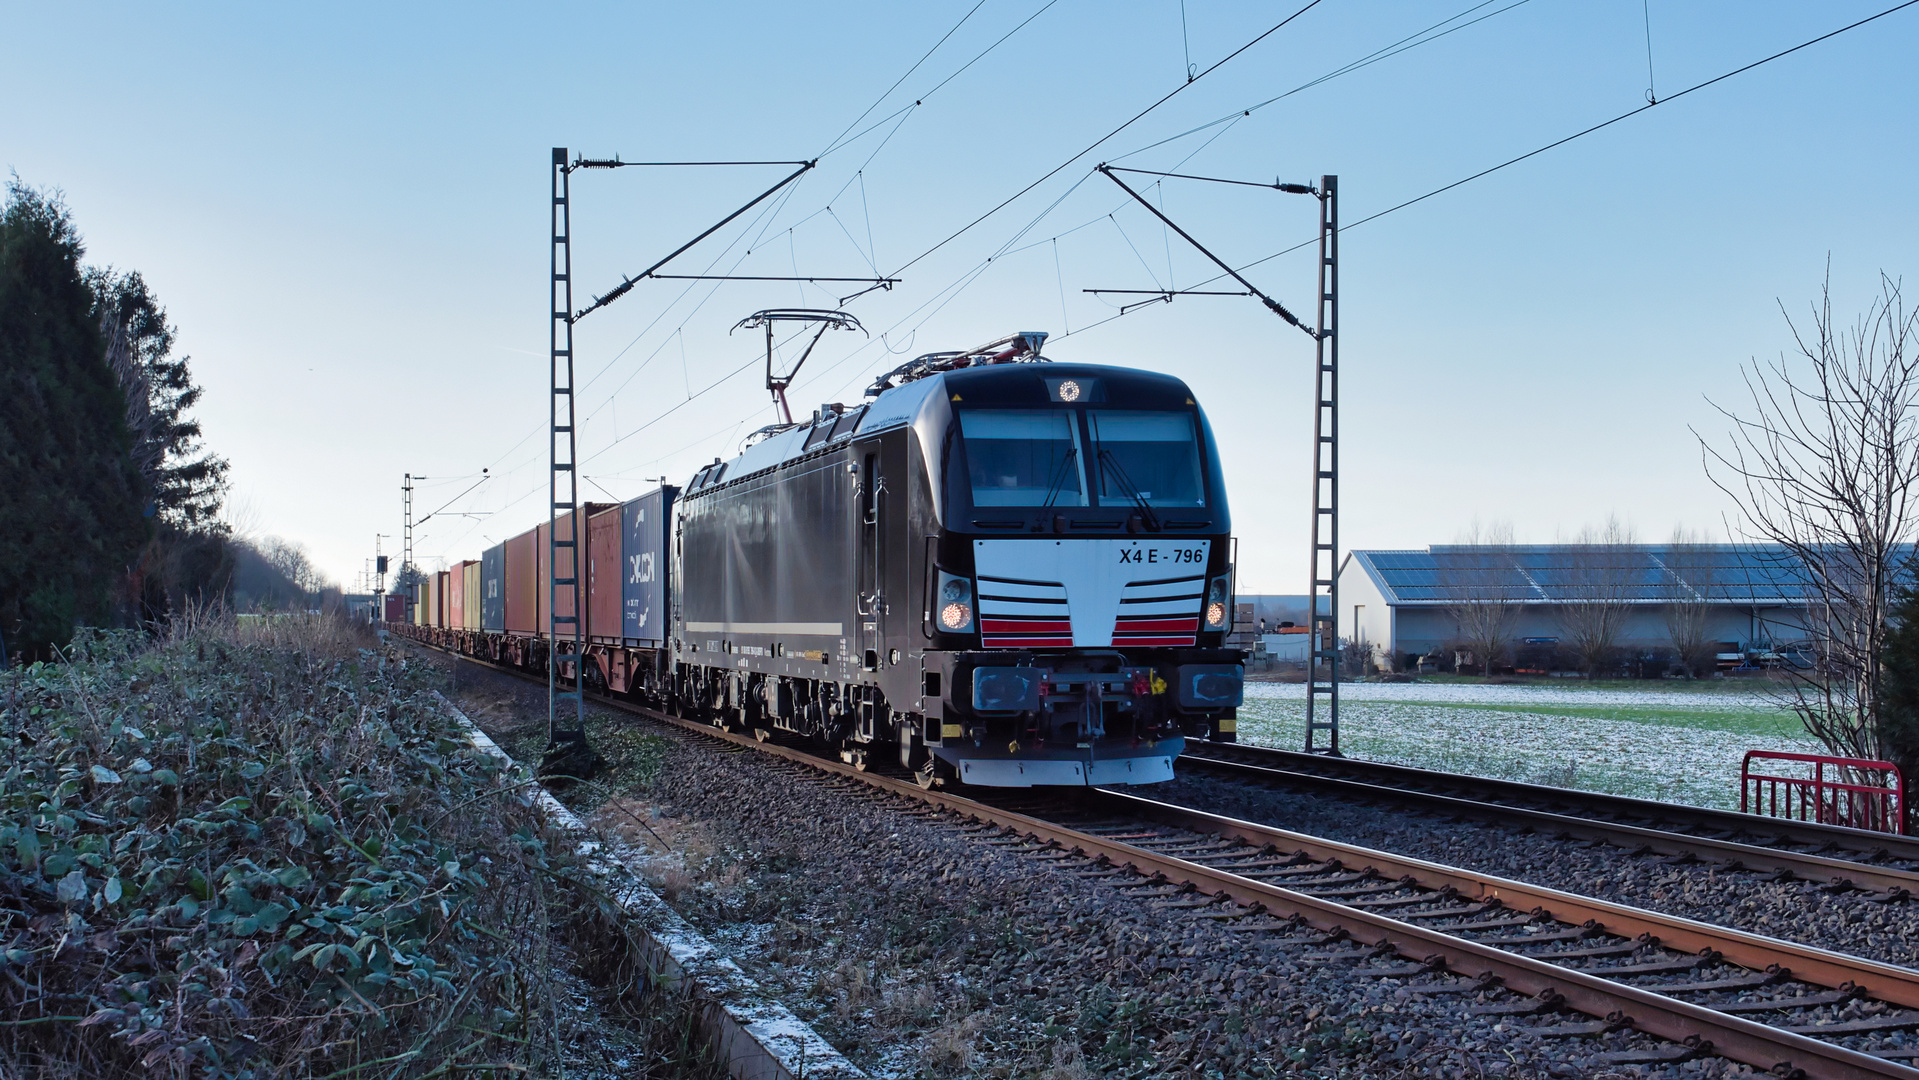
[403,334,1244,787]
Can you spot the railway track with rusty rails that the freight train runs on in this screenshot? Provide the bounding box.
[424,658,1919,1080]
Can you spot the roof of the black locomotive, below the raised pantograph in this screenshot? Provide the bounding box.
[683,361,1194,497]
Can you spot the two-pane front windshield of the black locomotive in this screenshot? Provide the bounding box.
[960,409,1205,506]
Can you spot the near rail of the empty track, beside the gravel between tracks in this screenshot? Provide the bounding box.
[1180,742,1919,898]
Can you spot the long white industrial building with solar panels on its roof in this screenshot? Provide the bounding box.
[1339,545,1808,671]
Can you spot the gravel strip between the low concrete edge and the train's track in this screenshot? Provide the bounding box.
[431,656,1780,1080]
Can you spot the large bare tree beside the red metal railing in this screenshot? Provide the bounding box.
[1700,274,1919,758]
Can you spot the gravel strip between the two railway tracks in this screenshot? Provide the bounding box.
[1148,775,1919,967]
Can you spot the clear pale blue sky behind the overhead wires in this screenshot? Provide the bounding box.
[0,0,1919,593]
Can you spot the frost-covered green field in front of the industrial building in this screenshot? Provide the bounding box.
[1240,683,1821,810]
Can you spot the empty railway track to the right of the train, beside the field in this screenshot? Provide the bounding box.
[1180,740,1919,902]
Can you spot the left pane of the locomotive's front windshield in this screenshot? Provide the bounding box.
[960,409,1082,506]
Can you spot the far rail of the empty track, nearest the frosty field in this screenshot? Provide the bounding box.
[1180,739,1919,863]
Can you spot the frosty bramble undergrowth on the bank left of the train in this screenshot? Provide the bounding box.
[0,618,713,1080]
